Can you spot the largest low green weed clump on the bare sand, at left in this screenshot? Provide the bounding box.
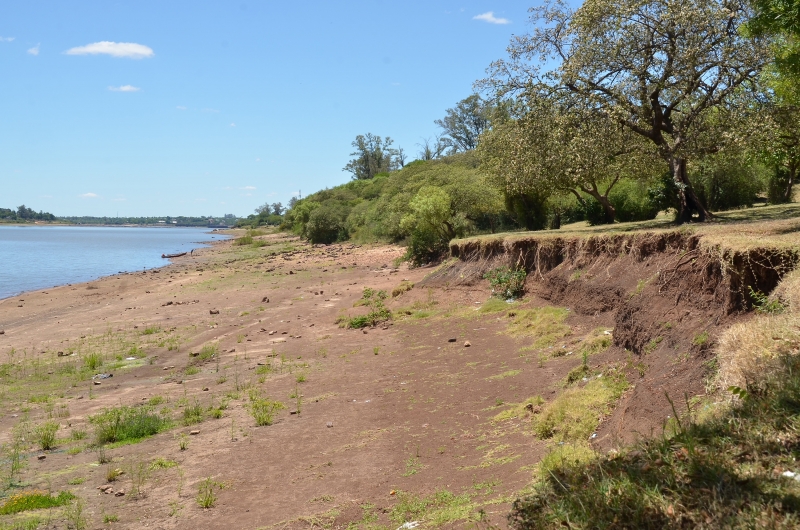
[89,405,170,445]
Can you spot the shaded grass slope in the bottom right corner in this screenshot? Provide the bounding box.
[511,356,800,530]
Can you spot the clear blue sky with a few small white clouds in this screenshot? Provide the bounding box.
[0,0,530,216]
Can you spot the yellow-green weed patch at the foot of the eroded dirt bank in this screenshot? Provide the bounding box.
[533,370,628,442]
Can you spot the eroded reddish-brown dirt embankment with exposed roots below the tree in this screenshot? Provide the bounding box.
[438,231,798,447]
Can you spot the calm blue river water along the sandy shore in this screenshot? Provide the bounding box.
[0,226,226,299]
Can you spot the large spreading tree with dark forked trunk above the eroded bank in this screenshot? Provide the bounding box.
[483,0,769,222]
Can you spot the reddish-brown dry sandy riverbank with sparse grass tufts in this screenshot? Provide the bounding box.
[0,230,720,529]
